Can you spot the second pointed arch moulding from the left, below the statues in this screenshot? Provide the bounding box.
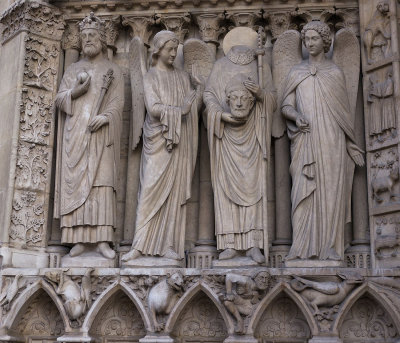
[82,280,153,333]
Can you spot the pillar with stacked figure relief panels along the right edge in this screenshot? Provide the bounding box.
[359,0,400,268]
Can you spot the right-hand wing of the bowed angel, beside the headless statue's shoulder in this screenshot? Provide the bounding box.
[183,38,215,81]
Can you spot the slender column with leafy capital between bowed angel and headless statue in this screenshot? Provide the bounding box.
[188,14,225,268]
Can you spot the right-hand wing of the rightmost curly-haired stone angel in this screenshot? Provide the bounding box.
[332,28,360,124]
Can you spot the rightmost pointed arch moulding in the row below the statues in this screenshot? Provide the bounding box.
[332,282,400,335]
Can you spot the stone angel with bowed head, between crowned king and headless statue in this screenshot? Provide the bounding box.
[122,30,208,265]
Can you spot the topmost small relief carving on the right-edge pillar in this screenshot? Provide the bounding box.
[363,0,391,64]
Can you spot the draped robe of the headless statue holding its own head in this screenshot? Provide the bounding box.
[204,52,276,254]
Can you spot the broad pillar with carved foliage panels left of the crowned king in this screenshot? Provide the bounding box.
[0,1,64,268]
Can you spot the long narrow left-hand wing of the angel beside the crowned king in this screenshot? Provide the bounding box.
[129,37,147,150]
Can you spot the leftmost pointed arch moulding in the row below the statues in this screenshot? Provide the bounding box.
[4,279,71,332]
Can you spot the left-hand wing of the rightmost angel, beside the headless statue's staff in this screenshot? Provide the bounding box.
[272,30,302,137]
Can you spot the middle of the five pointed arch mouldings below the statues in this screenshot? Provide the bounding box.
[165,281,234,334]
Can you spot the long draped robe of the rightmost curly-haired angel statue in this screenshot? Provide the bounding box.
[281,61,354,260]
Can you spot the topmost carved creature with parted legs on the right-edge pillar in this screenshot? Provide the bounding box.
[363,1,391,64]
